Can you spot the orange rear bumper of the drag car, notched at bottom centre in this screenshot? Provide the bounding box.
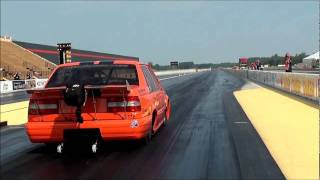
[26,116,152,143]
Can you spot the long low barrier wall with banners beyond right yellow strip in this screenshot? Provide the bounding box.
[228,69,320,101]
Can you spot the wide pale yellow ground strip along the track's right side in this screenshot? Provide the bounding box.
[234,87,319,179]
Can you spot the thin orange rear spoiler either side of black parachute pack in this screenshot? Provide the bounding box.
[27,82,131,94]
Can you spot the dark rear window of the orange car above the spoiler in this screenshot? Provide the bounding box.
[47,64,139,87]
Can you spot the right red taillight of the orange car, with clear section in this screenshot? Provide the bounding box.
[107,96,141,112]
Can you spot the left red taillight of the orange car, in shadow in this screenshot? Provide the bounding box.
[29,100,59,115]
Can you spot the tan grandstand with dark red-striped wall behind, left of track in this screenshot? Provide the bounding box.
[0,37,139,80]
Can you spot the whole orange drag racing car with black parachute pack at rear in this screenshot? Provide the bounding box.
[26,60,171,153]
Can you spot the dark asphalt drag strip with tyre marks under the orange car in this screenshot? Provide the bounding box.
[0,71,283,180]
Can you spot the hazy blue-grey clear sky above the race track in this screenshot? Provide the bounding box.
[1,0,319,65]
